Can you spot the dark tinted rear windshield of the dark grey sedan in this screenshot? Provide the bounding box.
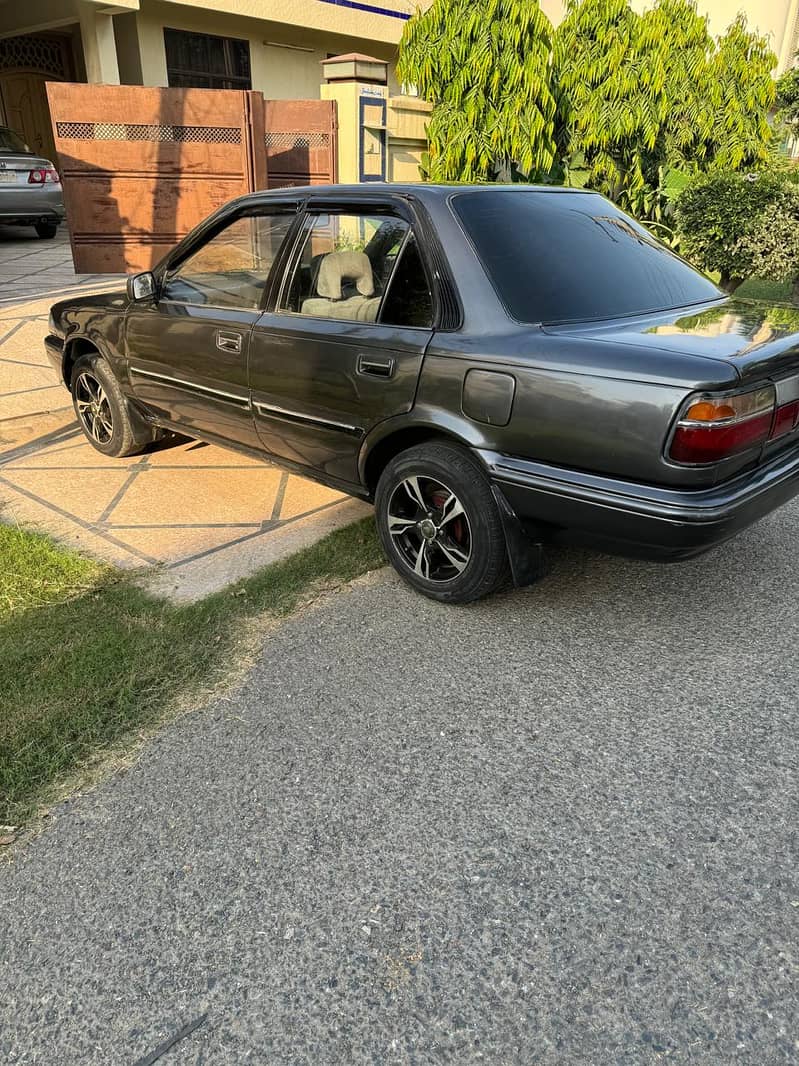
[453,189,722,324]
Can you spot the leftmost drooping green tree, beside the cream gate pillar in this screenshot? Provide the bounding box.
[397,0,556,181]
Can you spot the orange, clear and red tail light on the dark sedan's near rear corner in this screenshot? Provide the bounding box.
[669,385,775,464]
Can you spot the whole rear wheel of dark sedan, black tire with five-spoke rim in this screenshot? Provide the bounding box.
[375,441,510,603]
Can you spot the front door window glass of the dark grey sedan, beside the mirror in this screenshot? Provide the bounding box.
[161,211,296,310]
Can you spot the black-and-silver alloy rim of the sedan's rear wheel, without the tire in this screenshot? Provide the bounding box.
[388,475,472,583]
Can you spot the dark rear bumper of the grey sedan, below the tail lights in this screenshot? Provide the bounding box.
[479,448,799,560]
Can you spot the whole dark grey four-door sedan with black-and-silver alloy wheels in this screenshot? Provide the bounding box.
[47,184,799,602]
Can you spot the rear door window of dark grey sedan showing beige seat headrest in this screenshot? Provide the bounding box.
[280,213,409,322]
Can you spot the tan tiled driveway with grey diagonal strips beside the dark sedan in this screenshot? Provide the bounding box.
[0,225,369,599]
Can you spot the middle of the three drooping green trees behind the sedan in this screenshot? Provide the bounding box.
[555,0,667,210]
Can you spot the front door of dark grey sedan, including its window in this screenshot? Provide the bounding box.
[126,205,296,448]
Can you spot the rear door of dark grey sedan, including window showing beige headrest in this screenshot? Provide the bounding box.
[249,206,433,484]
